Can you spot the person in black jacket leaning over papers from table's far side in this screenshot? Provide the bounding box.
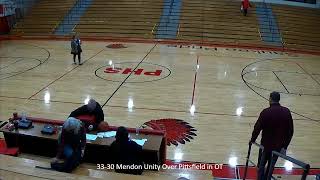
[69,99,104,130]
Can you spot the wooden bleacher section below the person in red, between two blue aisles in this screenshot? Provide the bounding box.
[178,0,263,44]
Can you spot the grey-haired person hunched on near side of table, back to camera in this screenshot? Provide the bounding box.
[51,117,86,173]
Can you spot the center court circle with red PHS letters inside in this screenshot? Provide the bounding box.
[95,62,171,83]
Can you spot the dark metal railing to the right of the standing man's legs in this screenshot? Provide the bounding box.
[267,151,310,180]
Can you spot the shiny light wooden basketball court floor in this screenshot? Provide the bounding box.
[0,40,320,168]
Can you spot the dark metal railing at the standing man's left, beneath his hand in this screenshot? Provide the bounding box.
[243,142,265,180]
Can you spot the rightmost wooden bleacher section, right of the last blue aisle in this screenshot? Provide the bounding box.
[272,5,320,50]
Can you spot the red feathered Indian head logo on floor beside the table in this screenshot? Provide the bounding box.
[144,118,197,146]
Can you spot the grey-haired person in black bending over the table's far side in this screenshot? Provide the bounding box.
[69,99,109,131]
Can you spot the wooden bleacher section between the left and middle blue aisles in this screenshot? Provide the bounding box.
[75,0,163,38]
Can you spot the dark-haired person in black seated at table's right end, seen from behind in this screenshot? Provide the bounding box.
[110,126,143,175]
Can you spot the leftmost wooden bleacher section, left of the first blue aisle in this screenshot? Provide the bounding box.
[11,0,76,35]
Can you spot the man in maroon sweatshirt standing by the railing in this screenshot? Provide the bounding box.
[249,92,294,179]
